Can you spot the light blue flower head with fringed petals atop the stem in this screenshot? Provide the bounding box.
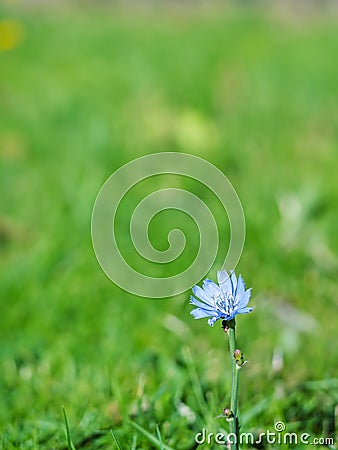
[190,270,253,327]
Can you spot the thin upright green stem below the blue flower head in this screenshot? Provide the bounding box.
[228,320,239,450]
